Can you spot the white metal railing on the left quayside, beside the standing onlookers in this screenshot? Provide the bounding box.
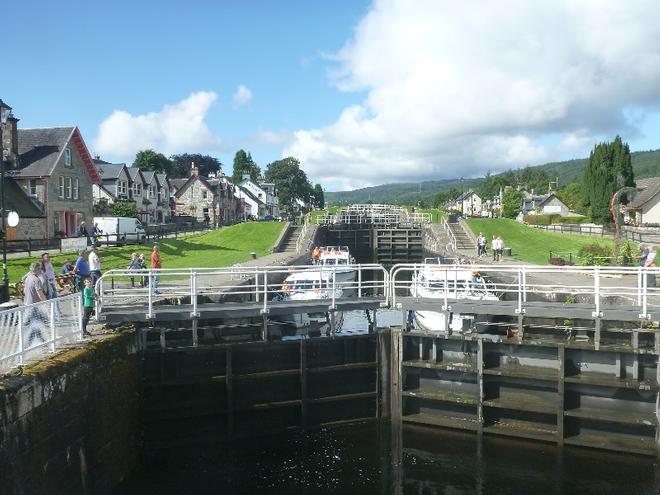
[0,294,83,371]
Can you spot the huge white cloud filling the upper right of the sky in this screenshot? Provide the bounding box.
[283,0,660,188]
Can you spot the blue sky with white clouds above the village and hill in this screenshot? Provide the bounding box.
[0,0,660,191]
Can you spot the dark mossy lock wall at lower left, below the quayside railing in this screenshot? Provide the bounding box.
[0,331,140,495]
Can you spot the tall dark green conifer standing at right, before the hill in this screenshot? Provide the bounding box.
[582,136,635,224]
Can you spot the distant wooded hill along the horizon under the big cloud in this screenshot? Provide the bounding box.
[325,149,660,204]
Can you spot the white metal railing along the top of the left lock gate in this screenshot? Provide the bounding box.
[95,264,390,318]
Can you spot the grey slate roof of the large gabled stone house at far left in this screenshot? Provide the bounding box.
[18,127,75,177]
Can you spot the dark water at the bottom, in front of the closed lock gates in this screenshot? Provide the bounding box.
[113,423,660,495]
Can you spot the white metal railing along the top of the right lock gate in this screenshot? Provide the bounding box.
[390,264,660,319]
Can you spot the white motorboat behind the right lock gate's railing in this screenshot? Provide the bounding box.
[410,258,499,333]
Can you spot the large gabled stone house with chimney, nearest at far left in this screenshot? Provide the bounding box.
[3,123,101,238]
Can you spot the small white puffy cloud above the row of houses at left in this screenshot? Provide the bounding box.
[94,91,219,160]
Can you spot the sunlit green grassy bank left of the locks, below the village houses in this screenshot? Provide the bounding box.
[7,222,285,282]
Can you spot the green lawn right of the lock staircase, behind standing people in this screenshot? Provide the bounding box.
[466,218,614,265]
